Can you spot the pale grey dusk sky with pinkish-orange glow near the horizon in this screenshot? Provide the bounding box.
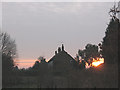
[2,2,114,67]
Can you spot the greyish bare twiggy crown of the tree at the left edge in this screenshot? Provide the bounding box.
[0,32,17,58]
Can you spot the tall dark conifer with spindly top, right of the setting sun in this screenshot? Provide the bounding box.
[102,3,120,64]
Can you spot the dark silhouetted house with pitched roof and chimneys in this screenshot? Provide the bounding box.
[48,44,77,73]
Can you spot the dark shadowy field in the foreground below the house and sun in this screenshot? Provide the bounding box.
[5,64,118,88]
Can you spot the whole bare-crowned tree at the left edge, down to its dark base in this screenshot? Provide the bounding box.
[0,32,16,69]
